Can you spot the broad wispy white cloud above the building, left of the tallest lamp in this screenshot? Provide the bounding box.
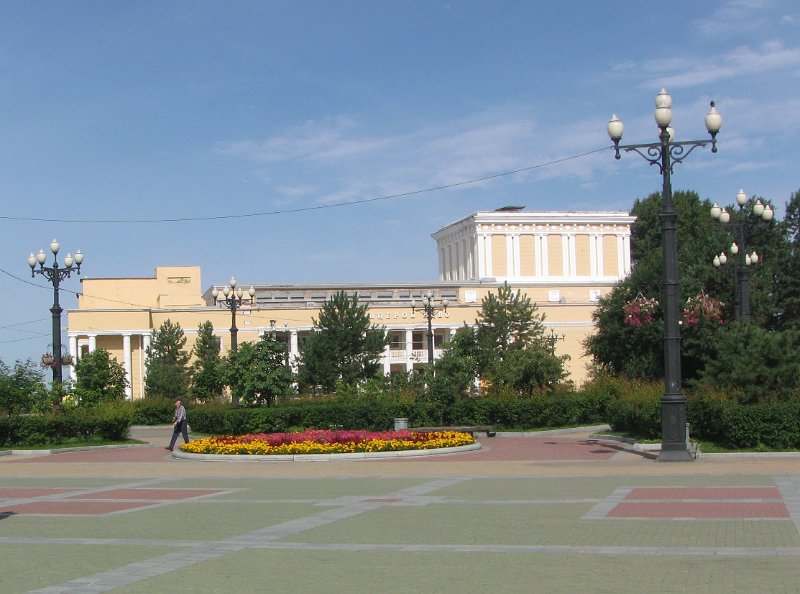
[218,105,624,206]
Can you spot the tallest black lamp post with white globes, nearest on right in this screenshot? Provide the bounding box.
[608,89,722,461]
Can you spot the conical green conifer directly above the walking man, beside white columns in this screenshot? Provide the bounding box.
[145,320,189,399]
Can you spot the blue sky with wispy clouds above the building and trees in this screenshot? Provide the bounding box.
[0,0,800,363]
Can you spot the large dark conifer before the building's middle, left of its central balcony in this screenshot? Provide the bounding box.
[298,291,389,391]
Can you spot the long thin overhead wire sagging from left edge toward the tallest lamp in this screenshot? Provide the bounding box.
[0,146,611,225]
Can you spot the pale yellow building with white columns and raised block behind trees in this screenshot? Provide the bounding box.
[67,207,634,398]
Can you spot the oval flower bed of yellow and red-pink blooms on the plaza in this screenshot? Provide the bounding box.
[180,430,475,456]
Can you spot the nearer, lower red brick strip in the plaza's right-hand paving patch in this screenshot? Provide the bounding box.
[608,501,789,519]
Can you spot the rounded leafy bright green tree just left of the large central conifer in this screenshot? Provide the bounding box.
[224,334,293,406]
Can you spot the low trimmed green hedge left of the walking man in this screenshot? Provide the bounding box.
[0,405,131,447]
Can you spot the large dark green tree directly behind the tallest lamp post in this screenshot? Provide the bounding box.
[584,191,792,384]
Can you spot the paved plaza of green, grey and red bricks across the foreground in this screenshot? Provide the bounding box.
[0,427,800,594]
